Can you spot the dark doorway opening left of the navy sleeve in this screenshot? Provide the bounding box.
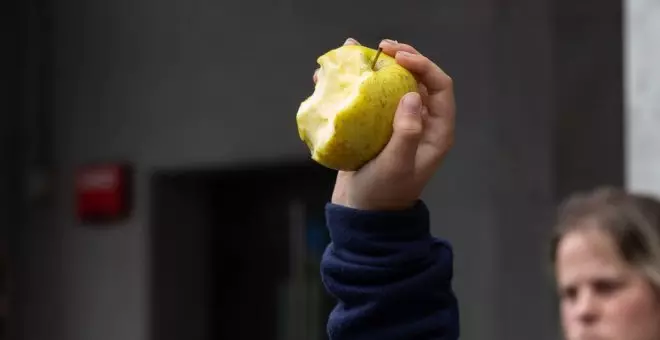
[151,162,335,340]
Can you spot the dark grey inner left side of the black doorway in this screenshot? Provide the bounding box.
[149,175,211,340]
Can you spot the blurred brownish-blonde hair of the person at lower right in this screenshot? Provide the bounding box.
[551,187,660,290]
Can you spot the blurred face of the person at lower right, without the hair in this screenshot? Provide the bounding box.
[555,223,660,340]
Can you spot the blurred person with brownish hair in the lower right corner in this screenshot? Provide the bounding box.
[551,188,660,340]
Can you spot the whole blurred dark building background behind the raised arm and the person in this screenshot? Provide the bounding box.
[0,0,660,340]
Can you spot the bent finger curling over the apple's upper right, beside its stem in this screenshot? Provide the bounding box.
[395,51,453,95]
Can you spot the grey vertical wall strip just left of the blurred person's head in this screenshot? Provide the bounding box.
[484,0,557,340]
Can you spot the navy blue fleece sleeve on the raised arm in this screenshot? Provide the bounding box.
[321,201,459,340]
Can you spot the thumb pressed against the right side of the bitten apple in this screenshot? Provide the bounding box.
[382,92,423,167]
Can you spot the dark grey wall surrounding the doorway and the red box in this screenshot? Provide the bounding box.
[12,0,624,340]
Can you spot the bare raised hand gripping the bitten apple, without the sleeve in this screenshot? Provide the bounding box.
[306,39,455,210]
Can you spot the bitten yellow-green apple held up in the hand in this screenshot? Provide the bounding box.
[296,45,418,171]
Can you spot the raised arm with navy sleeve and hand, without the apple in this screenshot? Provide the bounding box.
[314,39,459,340]
